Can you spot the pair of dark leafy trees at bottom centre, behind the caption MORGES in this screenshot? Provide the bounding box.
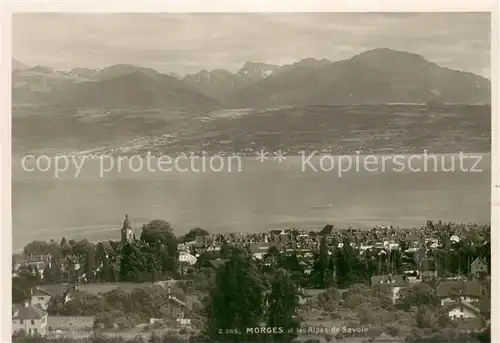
[200,248,299,342]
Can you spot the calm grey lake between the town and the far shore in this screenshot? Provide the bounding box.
[12,154,491,249]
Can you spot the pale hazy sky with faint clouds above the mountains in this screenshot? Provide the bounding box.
[13,13,490,77]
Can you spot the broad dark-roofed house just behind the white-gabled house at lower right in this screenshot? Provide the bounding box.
[436,280,481,306]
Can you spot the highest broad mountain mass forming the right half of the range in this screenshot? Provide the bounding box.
[229,49,491,107]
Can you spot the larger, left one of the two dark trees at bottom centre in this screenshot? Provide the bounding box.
[204,250,263,342]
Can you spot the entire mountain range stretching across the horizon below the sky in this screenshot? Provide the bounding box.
[12,48,491,112]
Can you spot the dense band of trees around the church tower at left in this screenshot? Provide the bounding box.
[13,220,177,290]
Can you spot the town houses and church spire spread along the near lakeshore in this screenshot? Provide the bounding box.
[12,215,490,342]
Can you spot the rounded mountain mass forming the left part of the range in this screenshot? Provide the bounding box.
[12,64,217,111]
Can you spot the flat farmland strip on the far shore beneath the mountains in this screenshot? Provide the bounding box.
[13,105,491,154]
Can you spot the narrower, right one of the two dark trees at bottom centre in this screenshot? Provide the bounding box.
[267,269,299,342]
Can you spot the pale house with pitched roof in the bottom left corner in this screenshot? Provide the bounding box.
[12,301,48,336]
